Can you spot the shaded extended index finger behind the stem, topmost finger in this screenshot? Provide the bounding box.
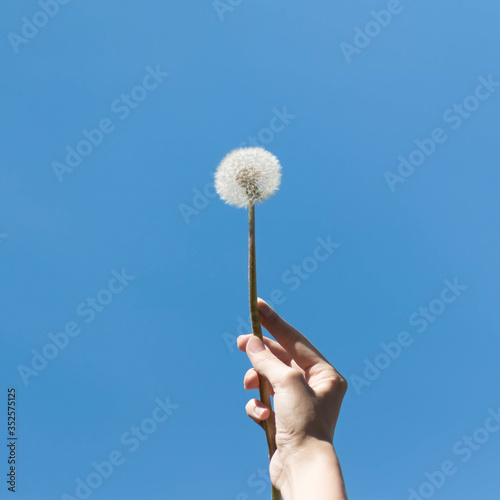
[258,299,331,373]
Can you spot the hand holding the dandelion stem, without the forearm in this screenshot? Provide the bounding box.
[237,299,347,488]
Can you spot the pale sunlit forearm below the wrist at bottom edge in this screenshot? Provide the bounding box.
[281,441,347,500]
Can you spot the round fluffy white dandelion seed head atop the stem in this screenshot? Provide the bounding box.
[215,148,281,207]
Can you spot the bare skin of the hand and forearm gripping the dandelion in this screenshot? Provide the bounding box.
[237,299,347,500]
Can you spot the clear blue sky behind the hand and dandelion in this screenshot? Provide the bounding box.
[0,0,500,500]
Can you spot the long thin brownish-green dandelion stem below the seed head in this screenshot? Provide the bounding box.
[248,203,281,500]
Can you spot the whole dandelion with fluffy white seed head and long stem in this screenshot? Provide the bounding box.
[215,148,281,500]
